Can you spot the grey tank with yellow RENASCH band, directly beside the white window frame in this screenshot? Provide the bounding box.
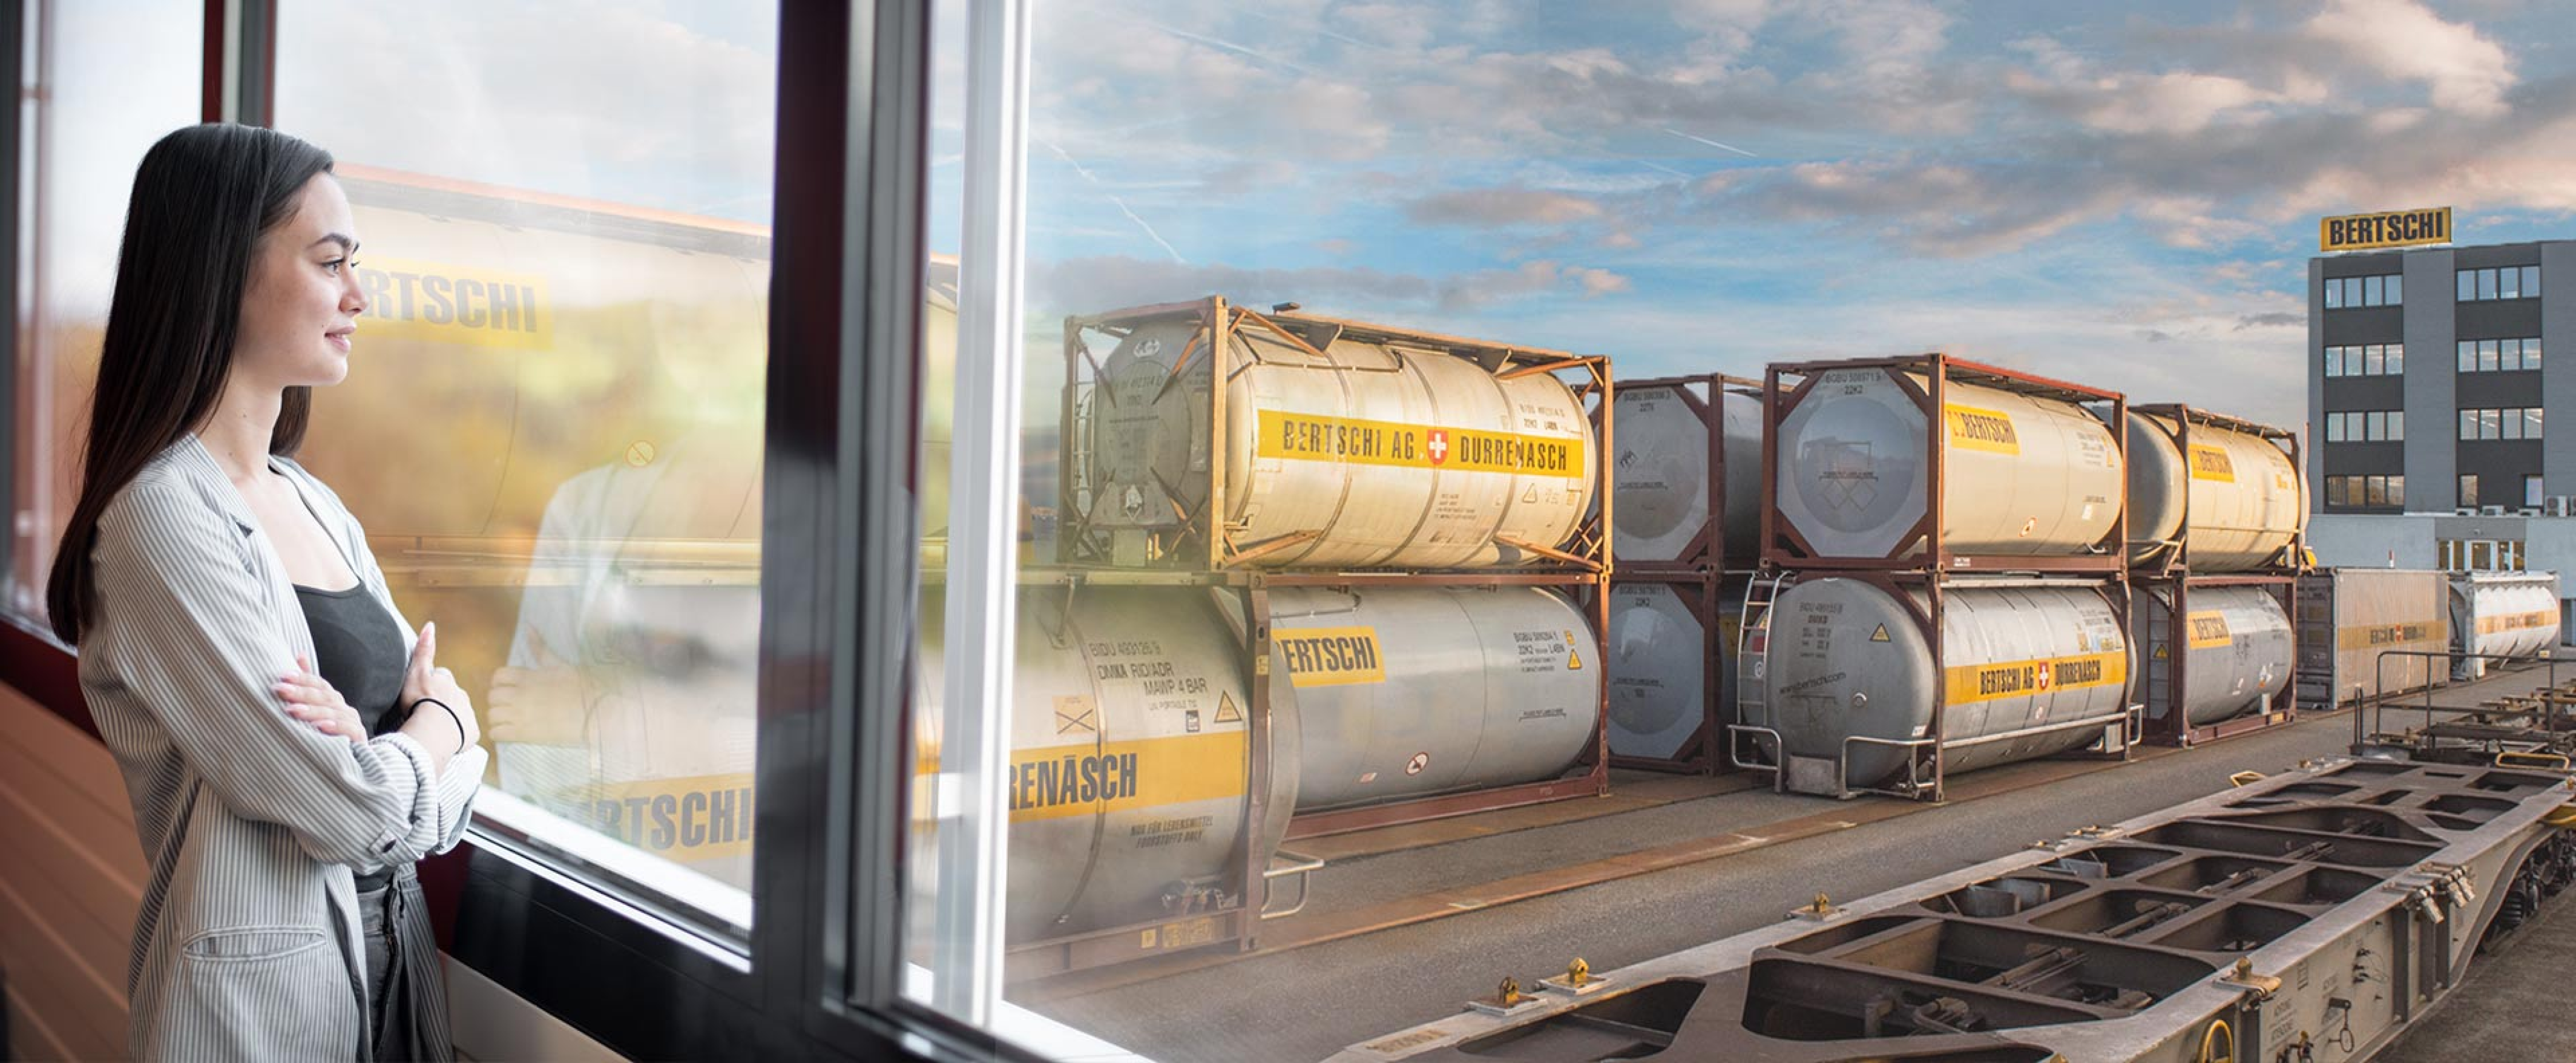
[914,586,1298,942]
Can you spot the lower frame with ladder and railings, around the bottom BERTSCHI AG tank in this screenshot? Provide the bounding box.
[1728,568,2143,805]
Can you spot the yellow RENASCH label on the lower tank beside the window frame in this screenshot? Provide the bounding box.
[1005,728,1244,823]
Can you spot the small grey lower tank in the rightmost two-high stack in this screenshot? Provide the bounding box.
[2130,583,2298,728]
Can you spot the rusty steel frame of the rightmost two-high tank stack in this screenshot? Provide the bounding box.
[2123,402,2308,746]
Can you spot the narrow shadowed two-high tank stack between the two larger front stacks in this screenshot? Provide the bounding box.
[1607,374,1762,774]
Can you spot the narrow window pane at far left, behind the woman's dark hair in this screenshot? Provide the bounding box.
[8,0,206,627]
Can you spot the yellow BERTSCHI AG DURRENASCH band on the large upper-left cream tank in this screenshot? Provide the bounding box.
[1255,410,1584,480]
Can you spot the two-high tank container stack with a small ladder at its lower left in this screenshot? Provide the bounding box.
[1728,353,2138,800]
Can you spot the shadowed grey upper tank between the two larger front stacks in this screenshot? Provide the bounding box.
[1610,387,1762,563]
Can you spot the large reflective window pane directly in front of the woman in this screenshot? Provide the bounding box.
[276,0,778,929]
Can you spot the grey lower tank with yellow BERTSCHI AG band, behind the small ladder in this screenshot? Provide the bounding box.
[1765,578,2128,795]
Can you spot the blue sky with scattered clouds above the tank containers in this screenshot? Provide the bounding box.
[933,0,2576,426]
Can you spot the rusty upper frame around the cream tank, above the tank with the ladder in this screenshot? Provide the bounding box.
[1762,351,2128,578]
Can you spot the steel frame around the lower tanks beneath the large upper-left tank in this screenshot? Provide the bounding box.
[1010,568,1610,983]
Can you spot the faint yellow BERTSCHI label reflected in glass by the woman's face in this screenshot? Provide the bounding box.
[358,256,554,351]
